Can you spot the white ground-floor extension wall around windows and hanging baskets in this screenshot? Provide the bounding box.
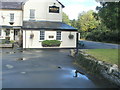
[23,30,77,48]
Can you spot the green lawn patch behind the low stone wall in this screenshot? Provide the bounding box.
[85,49,118,65]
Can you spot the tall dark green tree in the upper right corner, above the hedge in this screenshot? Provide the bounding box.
[96,2,120,31]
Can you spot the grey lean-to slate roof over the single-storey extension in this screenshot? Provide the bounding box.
[22,21,77,31]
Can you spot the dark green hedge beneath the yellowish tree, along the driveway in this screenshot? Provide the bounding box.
[86,26,120,43]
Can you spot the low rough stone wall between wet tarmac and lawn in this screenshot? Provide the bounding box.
[70,50,120,86]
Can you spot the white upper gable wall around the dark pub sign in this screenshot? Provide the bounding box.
[24,0,62,22]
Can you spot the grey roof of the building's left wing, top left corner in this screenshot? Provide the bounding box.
[0,2,22,10]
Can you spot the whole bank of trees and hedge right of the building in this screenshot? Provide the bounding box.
[63,2,120,43]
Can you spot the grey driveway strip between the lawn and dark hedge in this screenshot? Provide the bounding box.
[80,40,120,49]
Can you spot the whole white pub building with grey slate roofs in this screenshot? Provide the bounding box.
[0,0,78,48]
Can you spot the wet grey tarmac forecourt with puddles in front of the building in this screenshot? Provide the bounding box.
[2,49,115,88]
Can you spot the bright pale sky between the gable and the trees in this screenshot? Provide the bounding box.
[59,0,100,19]
